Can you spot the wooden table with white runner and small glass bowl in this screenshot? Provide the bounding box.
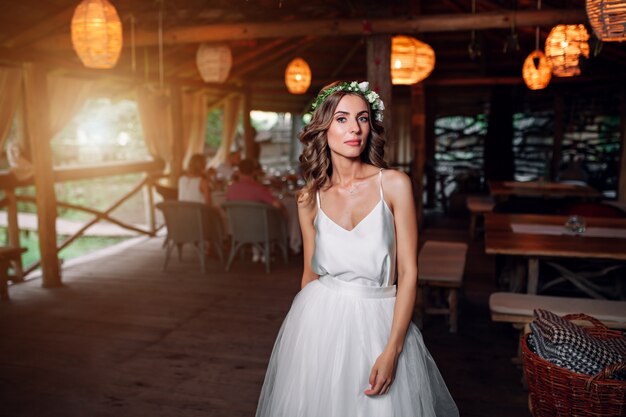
[485,213,626,298]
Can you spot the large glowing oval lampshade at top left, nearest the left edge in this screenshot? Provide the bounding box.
[72,0,122,68]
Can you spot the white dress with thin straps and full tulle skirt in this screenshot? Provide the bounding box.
[256,171,459,417]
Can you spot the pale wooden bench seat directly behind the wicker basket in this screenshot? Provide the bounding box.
[489,292,626,329]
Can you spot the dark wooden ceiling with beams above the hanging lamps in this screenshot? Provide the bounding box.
[0,0,626,112]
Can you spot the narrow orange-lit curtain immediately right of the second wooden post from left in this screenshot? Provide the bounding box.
[182,92,207,166]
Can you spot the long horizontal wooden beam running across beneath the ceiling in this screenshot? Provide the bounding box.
[37,9,587,49]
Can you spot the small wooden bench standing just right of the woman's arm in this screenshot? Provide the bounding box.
[416,240,467,333]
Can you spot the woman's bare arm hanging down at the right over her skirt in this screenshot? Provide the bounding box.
[365,170,417,395]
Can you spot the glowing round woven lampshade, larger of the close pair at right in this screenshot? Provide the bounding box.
[546,25,589,77]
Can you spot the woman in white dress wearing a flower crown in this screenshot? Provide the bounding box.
[256,82,458,417]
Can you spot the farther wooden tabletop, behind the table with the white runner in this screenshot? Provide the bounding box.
[489,181,602,200]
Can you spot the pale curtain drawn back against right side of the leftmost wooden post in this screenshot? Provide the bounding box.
[48,75,95,139]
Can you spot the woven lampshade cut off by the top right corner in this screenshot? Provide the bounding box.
[585,0,626,42]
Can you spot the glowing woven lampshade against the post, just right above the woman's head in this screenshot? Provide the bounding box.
[391,35,435,85]
